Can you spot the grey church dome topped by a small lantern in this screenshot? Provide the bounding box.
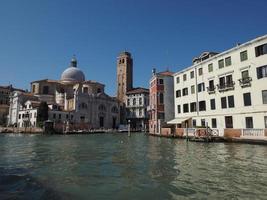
[61,58,85,82]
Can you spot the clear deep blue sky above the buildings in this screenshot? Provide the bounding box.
[0,0,267,95]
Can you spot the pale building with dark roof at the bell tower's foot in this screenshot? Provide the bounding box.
[125,87,149,130]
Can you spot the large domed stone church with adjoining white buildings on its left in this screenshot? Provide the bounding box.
[9,58,120,129]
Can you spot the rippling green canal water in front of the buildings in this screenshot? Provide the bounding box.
[0,133,267,200]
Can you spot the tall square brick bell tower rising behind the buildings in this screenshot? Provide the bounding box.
[117,51,133,103]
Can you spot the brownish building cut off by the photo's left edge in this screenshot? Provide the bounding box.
[0,85,24,125]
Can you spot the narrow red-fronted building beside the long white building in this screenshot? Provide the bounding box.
[149,69,174,134]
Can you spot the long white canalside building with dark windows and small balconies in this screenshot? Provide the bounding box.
[168,35,267,136]
